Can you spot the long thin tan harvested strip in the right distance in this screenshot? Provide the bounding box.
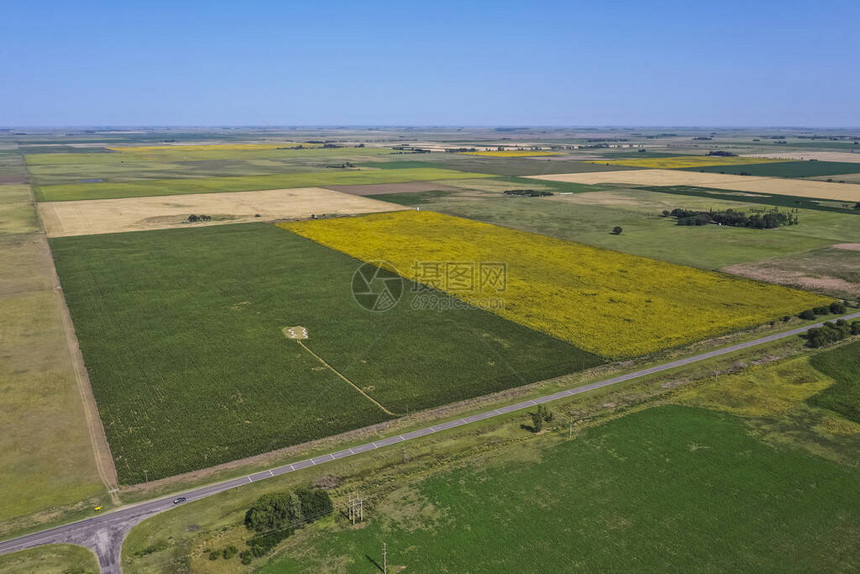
[530,169,860,201]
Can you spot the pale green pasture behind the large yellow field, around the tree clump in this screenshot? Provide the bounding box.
[388,187,860,272]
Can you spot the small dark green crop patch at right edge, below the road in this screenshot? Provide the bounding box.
[809,341,860,423]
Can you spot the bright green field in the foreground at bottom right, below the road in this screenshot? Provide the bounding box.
[260,406,860,574]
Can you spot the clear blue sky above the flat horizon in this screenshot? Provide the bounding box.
[0,0,860,127]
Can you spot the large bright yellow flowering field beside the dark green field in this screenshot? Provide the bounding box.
[278,211,831,358]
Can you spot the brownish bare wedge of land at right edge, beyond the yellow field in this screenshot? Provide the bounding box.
[722,248,860,299]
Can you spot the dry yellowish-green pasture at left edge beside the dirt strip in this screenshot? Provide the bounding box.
[0,185,105,536]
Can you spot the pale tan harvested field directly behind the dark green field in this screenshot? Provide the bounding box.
[39,187,406,237]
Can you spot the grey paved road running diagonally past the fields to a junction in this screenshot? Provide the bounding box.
[0,312,860,574]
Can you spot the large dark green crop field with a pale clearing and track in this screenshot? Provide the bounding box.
[52,224,601,484]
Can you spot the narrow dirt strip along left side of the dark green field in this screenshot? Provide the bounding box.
[19,150,120,504]
